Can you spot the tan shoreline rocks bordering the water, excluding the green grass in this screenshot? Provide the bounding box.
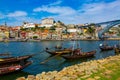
[16,55,120,80]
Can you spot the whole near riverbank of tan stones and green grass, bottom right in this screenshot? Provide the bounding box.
[16,55,120,80]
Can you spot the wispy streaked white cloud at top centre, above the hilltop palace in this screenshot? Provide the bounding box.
[33,0,76,15]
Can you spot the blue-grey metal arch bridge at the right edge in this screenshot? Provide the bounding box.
[96,20,120,39]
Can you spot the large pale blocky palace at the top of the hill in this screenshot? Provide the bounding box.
[41,18,54,27]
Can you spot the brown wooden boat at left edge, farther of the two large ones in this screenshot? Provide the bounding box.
[0,55,33,64]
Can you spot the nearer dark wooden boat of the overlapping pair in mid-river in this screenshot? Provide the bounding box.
[62,49,96,59]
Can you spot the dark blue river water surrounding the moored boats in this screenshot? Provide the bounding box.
[0,40,118,80]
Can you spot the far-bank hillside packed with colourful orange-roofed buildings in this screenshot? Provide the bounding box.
[0,18,120,41]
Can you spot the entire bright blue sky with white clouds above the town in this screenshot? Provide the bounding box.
[0,0,120,26]
